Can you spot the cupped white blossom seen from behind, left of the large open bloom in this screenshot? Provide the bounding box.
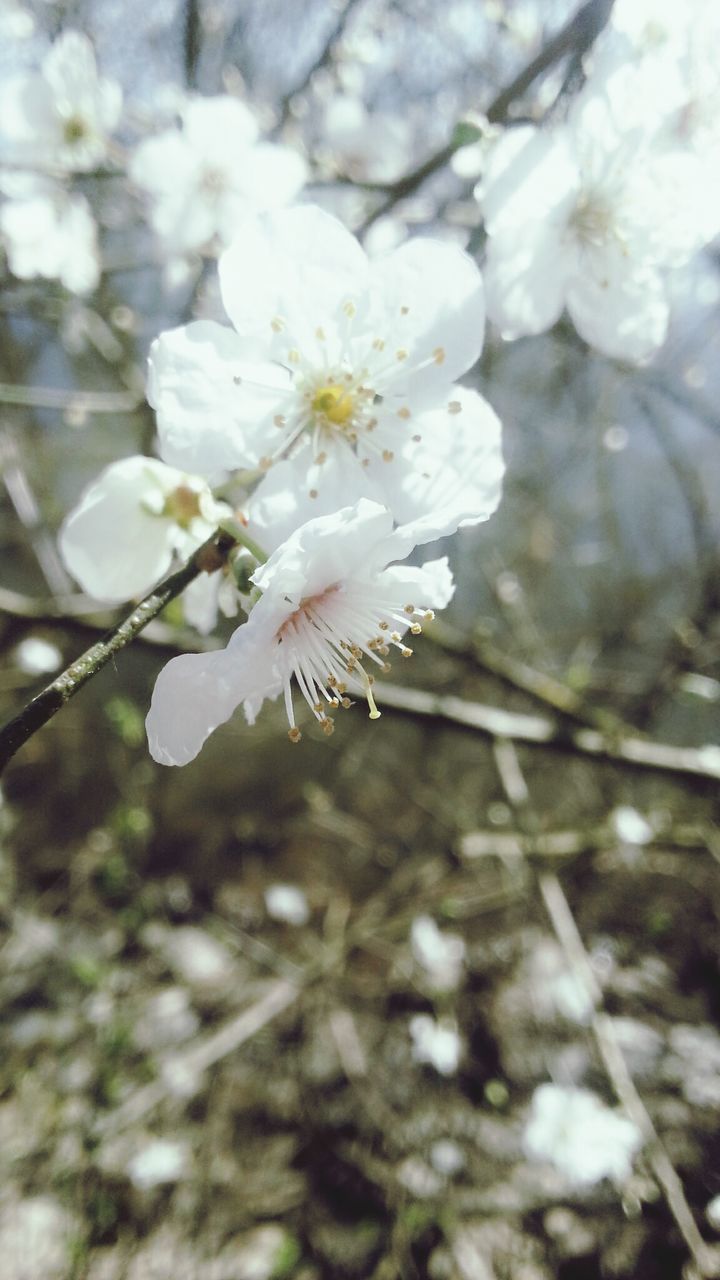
[59,457,229,604]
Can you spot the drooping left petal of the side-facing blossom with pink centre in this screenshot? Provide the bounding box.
[145,634,279,764]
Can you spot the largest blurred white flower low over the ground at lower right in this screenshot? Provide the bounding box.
[523,1084,643,1187]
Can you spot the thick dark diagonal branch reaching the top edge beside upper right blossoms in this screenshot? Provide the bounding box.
[363,0,614,232]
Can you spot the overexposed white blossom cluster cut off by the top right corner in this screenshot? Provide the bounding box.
[477,0,720,362]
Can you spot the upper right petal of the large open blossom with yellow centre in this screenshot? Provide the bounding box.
[369,238,486,396]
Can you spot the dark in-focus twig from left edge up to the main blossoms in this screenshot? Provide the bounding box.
[0,530,236,773]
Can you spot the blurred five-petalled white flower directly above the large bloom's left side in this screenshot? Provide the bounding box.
[129,97,307,253]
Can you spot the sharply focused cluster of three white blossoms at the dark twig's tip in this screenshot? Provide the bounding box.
[60,205,503,764]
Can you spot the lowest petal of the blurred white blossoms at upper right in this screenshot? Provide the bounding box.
[568,253,670,364]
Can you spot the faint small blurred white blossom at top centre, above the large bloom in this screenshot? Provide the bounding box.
[320,93,413,183]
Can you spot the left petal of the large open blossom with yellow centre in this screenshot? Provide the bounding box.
[147,320,290,476]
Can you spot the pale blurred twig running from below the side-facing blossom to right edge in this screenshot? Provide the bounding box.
[374,682,720,780]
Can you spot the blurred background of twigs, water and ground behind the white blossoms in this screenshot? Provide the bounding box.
[0,0,720,1280]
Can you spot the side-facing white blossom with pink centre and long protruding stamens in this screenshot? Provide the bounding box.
[146,499,452,764]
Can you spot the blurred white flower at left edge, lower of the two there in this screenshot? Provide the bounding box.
[0,186,100,294]
